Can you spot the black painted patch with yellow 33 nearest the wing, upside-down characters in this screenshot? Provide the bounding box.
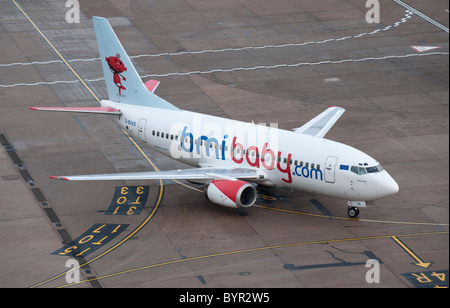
[105,186,150,215]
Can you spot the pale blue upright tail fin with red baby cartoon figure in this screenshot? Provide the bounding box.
[92,16,178,109]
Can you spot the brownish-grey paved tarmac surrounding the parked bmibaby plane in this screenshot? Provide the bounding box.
[0,0,449,288]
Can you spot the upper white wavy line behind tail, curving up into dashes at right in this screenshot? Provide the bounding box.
[0,10,413,67]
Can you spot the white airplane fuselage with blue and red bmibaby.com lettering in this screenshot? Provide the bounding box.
[102,100,398,201]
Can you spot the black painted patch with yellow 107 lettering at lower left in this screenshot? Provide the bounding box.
[51,223,129,258]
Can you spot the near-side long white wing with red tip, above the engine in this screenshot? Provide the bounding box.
[50,168,263,181]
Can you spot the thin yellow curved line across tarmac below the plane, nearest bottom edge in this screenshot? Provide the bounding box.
[59,231,448,288]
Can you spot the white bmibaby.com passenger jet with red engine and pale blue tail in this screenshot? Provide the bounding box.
[28,16,399,218]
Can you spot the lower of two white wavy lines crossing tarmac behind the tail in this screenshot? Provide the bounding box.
[0,51,449,88]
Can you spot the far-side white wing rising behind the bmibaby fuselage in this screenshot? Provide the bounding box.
[293,106,345,138]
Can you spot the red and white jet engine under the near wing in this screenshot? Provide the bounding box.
[205,180,257,208]
